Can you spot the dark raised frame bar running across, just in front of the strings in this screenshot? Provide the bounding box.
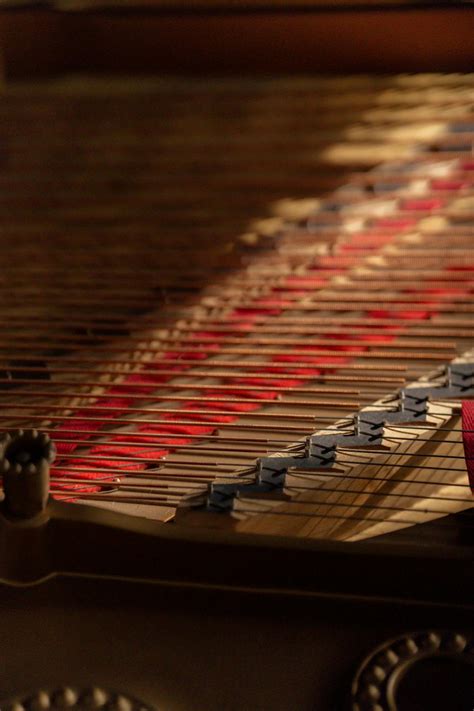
[0,501,473,608]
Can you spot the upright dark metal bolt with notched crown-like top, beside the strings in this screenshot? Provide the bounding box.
[0,430,56,519]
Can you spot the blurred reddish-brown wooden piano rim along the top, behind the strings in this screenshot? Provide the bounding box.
[0,0,474,79]
